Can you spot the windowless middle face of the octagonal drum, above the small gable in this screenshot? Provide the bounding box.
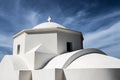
[25,33,57,54]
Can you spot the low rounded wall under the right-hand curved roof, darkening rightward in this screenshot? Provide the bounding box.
[64,68,120,80]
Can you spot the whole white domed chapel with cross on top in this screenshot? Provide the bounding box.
[0,17,120,80]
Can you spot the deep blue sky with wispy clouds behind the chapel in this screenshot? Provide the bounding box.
[0,0,120,60]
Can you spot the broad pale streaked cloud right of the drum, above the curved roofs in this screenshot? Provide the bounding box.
[84,22,120,57]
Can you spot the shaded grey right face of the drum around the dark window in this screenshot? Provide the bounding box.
[57,32,83,53]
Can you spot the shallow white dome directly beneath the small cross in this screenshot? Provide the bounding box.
[33,22,65,29]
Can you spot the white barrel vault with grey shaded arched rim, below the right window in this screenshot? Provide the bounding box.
[44,48,105,68]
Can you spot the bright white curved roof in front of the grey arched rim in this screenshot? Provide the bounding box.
[67,53,120,69]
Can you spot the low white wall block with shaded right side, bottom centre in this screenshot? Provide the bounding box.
[32,69,63,80]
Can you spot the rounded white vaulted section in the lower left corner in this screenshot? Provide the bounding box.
[0,55,27,80]
